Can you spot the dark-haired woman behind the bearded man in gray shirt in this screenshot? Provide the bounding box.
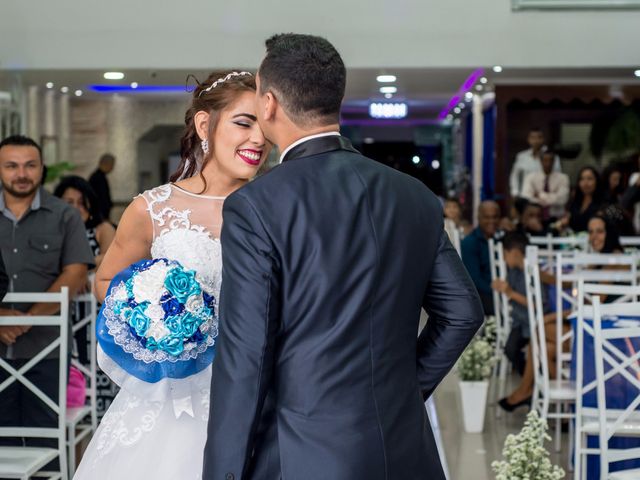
[53,175,116,268]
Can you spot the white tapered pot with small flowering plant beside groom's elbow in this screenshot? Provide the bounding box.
[458,335,495,433]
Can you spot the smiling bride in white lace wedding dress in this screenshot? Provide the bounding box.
[74,72,269,480]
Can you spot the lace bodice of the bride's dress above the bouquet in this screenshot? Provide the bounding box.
[142,183,224,299]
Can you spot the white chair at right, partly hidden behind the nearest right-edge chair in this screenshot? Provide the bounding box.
[573,279,640,480]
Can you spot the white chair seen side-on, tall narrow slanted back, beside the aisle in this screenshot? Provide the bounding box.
[525,246,576,458]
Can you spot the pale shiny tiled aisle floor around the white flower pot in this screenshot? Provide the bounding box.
[435,373,573,480]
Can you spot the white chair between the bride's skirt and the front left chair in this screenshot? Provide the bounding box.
[66,293,98,478]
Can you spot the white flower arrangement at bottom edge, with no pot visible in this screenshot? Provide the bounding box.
[491,410,565,480]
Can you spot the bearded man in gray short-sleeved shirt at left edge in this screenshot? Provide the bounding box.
[0,136,93,445]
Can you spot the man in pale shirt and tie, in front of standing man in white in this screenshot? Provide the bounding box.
[521,150,569,221]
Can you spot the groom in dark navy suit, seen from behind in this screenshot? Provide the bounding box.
[203,34,483,480]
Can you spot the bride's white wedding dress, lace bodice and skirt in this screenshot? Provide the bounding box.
[74,184,224,480]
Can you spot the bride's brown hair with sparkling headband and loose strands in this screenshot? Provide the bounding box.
[170,70,256,184]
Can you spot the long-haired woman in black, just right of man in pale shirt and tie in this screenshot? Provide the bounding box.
[560,167,603,233]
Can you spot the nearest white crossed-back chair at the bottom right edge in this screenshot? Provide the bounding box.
[593,297,640,480]
